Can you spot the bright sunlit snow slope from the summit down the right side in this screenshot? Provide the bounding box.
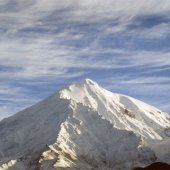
[60,79,170,140]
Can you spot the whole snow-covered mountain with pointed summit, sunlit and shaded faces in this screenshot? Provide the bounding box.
[0,79,170,170]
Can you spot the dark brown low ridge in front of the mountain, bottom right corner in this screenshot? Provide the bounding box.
[134,162,170,170]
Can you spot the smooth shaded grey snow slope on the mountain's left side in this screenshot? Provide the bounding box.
[0,95,71,170]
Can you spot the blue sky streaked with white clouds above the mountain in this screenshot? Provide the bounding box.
[0,0,170,119]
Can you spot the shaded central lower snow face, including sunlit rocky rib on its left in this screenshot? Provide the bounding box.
[40,103,156,170]
